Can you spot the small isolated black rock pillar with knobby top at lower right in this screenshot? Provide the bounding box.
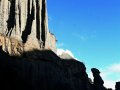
[91,68,105,90]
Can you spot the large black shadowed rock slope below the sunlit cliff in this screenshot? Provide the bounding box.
[0,50,91,90]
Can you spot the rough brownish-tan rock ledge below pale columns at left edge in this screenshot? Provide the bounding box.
[0,34,24,55]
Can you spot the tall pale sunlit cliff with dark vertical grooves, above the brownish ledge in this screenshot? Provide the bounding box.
[0,0,56,54]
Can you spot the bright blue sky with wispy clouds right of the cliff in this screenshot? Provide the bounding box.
[47,0,120,88]
